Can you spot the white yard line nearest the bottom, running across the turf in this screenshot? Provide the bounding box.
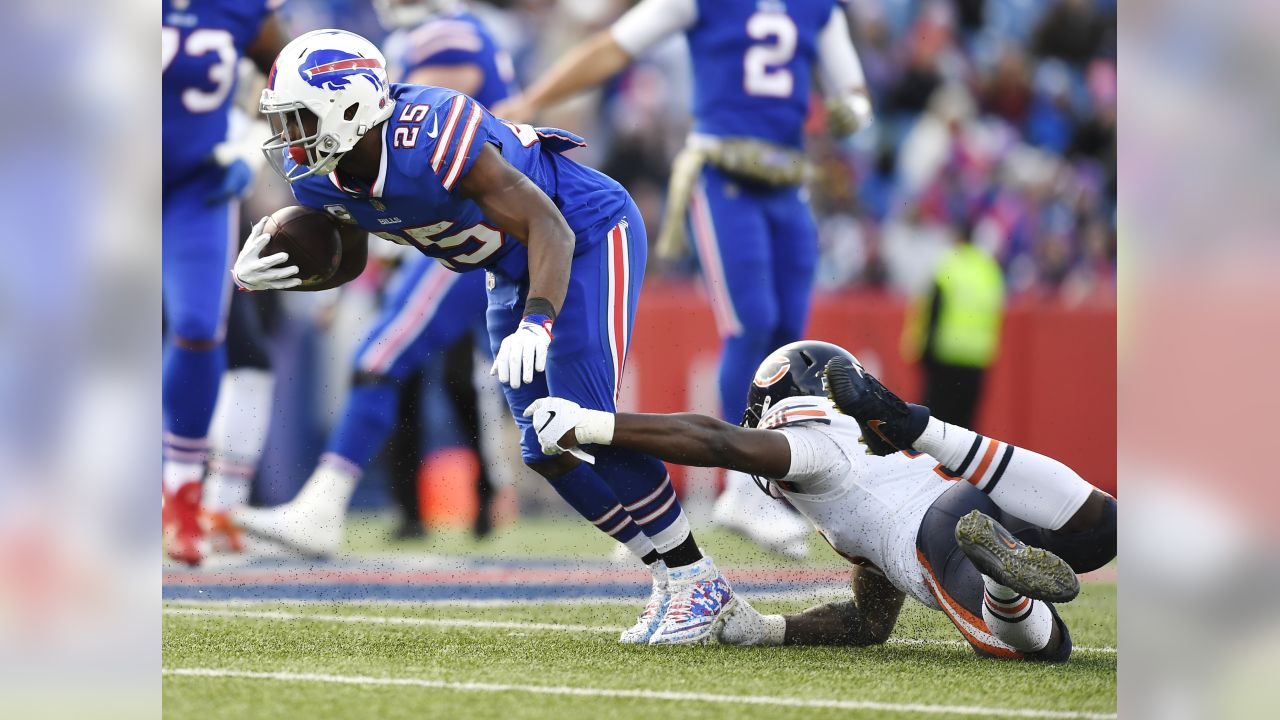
[163,667,1116,720]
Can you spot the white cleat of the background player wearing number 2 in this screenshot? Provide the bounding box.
[712,470,813,560]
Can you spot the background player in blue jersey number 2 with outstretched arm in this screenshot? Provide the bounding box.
[495,0,872,555]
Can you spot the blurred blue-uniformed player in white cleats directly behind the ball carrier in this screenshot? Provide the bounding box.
[234,0,512,556]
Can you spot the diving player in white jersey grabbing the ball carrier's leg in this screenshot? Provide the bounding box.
[529,341,1117,661]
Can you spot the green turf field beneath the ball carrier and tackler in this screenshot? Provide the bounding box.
[163,521,1116,720]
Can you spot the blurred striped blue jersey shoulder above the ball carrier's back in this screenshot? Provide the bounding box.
[383,12,515,108]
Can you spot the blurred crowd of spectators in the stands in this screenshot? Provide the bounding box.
[267,0,1116,304]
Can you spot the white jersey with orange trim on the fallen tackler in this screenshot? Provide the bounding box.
[760,397,955,609]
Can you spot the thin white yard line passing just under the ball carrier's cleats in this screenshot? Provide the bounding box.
[164,606,1116,655]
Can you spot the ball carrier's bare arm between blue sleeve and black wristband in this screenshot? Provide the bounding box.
[461,143,576,313]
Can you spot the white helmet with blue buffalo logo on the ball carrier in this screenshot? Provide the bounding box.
[260,29,396,183]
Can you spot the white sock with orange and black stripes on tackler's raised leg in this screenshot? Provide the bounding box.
[915,418,1093,530]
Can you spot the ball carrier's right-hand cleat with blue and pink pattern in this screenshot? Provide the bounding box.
[649,557,737,644]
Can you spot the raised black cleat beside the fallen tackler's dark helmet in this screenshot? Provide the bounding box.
[823,355,929,455]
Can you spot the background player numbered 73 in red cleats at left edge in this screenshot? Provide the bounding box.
[160,0,285,565]
